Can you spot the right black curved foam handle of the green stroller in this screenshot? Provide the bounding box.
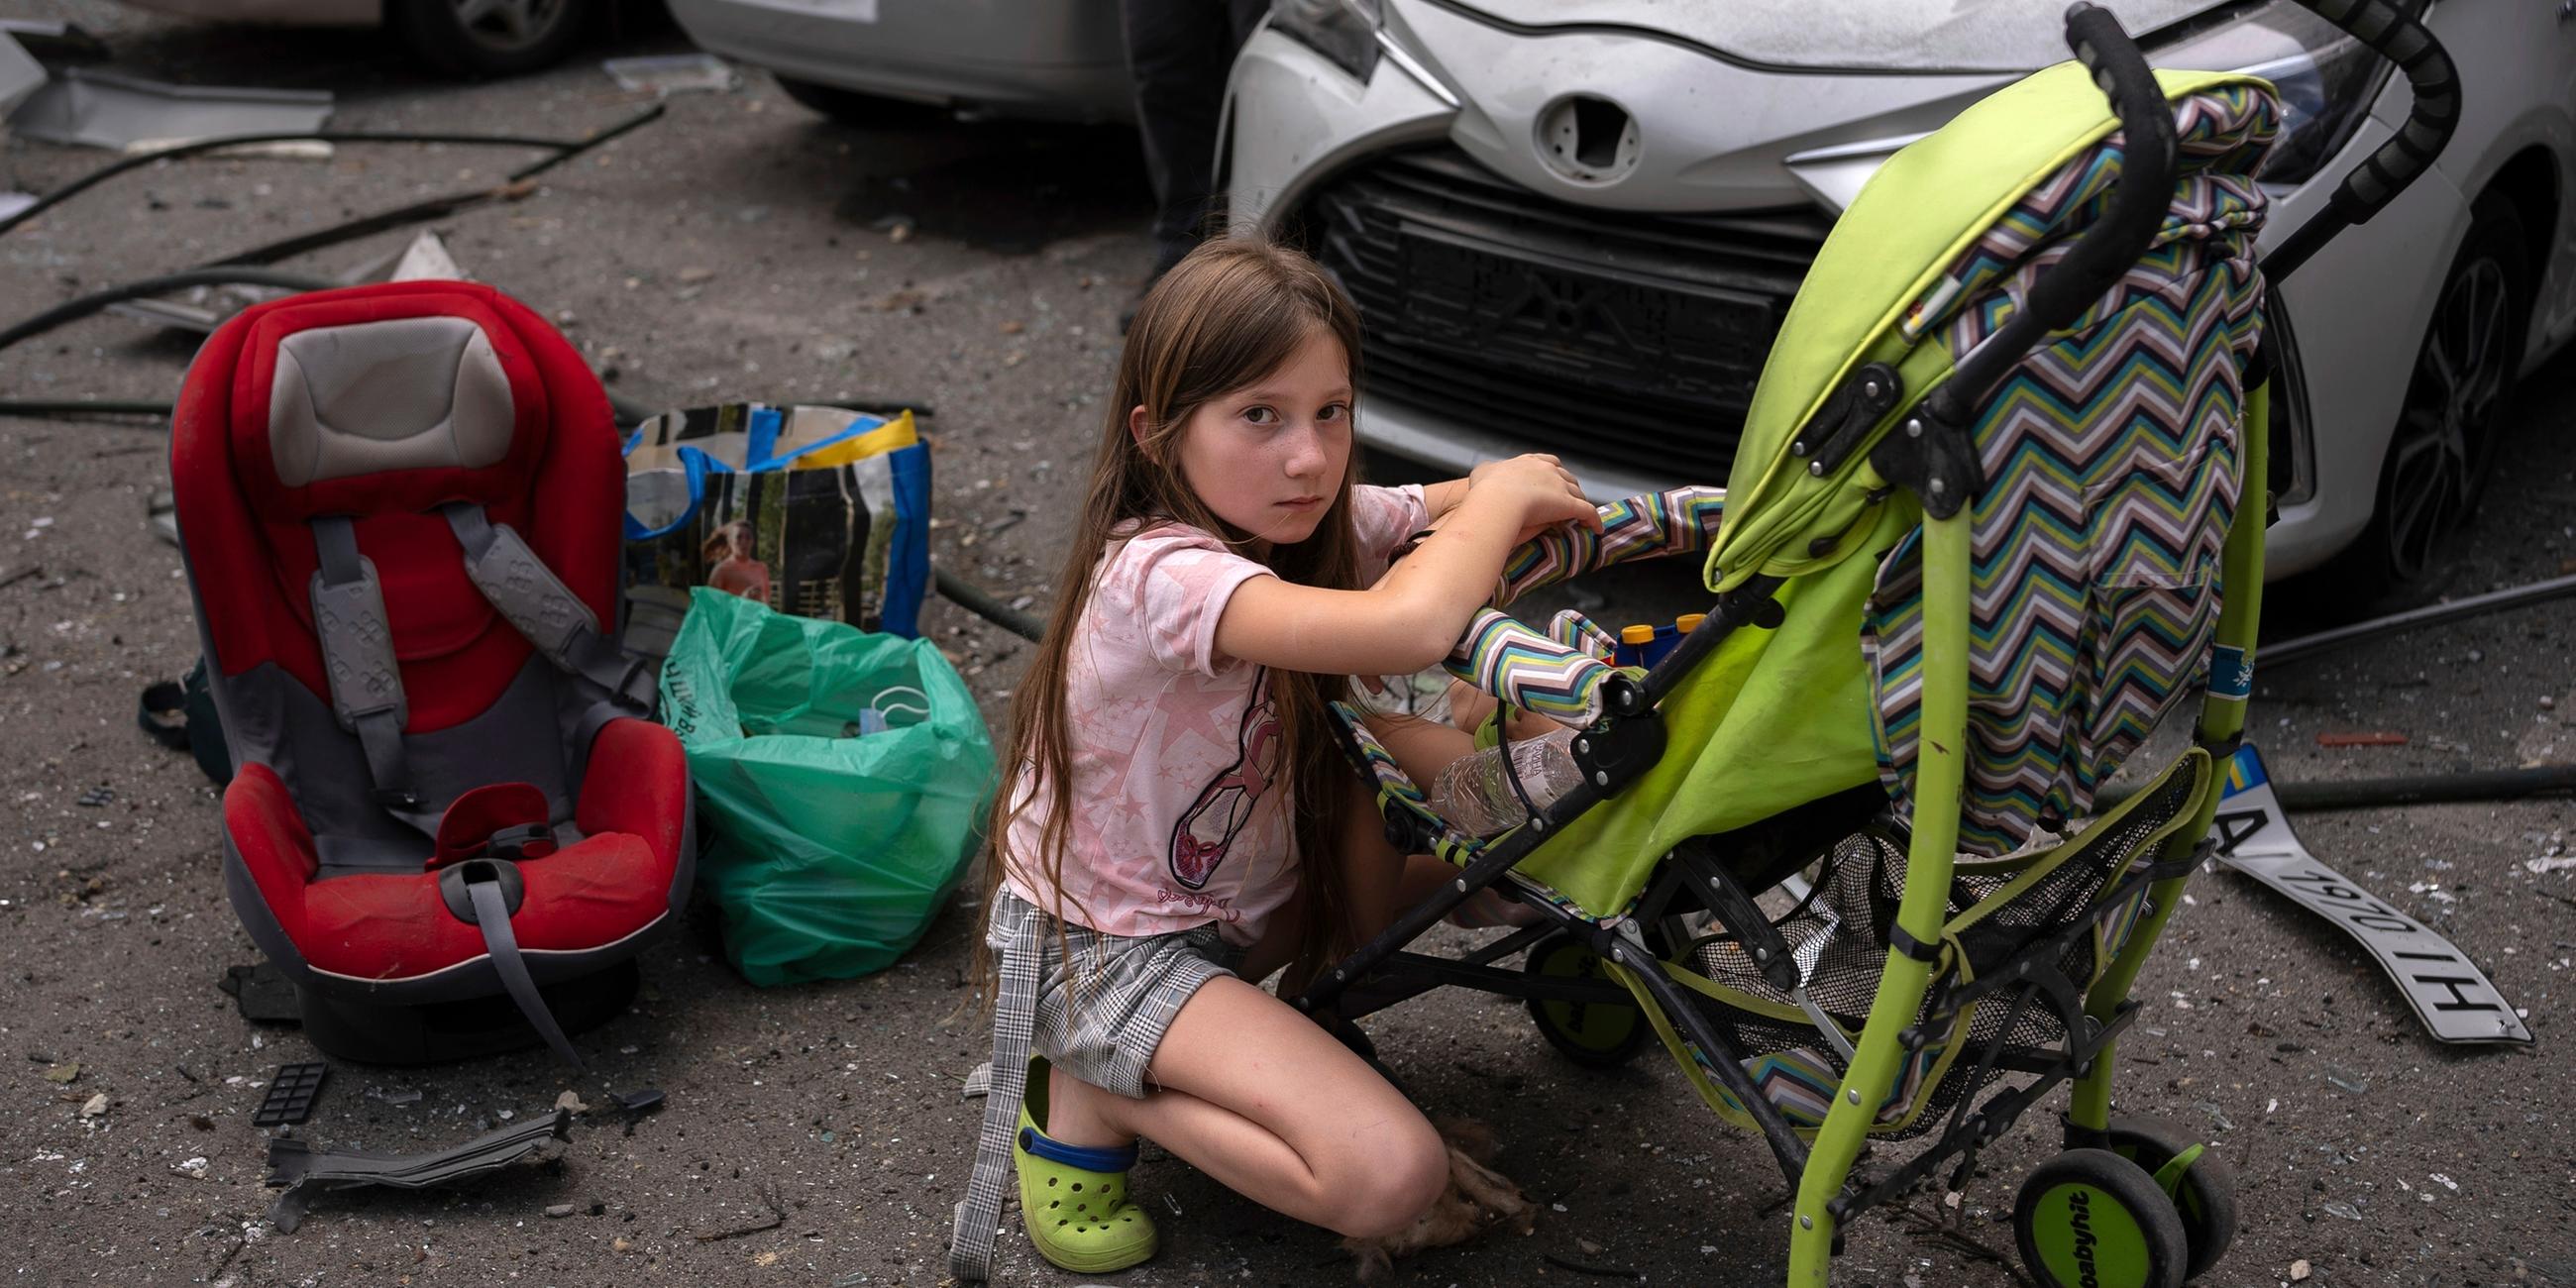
[2262,0,2460,280]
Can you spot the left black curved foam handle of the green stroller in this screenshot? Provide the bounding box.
[1924,0,2174,425]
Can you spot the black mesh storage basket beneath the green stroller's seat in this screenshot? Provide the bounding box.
[1682,763,2202,1138]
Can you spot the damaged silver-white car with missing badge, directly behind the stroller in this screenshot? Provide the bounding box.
[1221,0,2576,597]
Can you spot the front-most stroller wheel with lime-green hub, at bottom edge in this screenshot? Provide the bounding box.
[2012,1149,2190,1288]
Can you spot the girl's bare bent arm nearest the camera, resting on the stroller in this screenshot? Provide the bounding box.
[1216,456,1600,675]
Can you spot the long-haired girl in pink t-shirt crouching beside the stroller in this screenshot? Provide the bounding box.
[950,240,1600,1280]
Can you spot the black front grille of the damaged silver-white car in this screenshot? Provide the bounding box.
[1280,147,1832,482]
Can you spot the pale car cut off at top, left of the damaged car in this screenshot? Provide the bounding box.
[670,0,1133,121]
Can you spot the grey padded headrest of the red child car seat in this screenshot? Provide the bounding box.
[268,317,512,486]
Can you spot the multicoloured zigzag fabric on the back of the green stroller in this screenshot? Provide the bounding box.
[1863,87,2280,855]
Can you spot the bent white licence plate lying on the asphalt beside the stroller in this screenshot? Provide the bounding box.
[2215,742,2532,1043]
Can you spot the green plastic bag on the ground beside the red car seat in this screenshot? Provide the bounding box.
[662,588,995,987]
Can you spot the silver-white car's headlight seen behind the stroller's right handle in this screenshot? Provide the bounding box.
[2148,0,2424,183]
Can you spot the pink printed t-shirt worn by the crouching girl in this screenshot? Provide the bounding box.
[1008,486,1430,943]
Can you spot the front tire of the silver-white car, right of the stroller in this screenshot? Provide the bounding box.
[2318,193,2529,608]
